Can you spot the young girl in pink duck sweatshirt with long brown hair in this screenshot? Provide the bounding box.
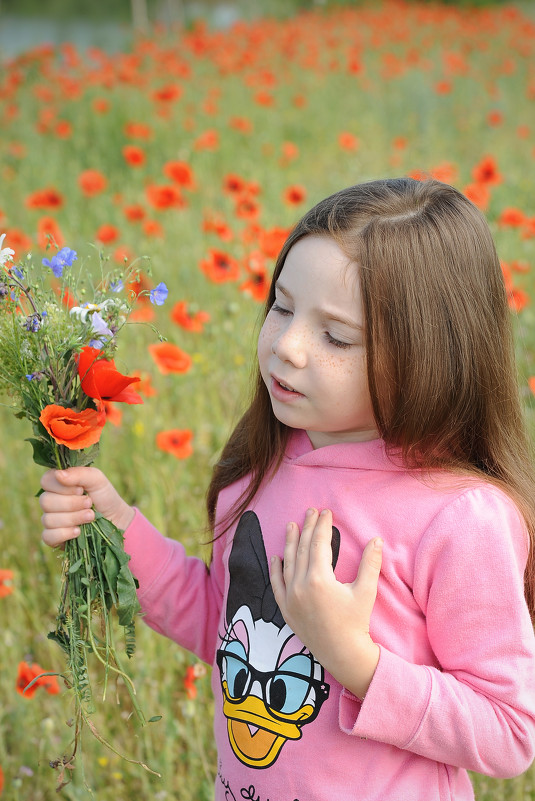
[40,179,535,801]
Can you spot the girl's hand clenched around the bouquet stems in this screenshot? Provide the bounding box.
[39,467,135,547]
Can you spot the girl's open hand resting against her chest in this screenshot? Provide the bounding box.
[271,509,383,698]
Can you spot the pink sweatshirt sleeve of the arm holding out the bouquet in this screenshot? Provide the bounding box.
[125,509,224,663]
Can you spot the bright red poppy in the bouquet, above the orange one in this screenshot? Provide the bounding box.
[78,346,143,403]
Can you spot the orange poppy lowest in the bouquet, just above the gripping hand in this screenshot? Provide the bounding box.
[39,403,106,450]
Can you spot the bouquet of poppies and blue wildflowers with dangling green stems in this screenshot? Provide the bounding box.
[0,235,167,779]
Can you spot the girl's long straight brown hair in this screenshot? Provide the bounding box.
[207,178,535,615]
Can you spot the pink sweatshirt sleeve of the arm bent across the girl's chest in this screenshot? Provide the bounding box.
[340,487,535,778]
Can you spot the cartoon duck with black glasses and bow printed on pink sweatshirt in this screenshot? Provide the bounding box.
[216,511,340,768]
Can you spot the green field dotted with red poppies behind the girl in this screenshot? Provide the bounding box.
[0,0,535,801]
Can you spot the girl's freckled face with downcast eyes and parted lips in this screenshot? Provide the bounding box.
[258,236,379,448]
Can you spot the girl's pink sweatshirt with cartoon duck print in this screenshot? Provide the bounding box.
[126,431,535,801]
